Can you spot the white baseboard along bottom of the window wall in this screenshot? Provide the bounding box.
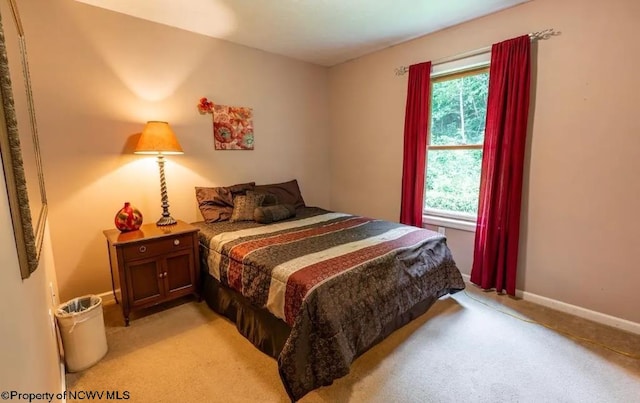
[462,274,640,334]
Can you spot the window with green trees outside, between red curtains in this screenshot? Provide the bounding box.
[424,64,489,226]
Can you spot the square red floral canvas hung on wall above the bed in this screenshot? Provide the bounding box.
[212,105,253,150]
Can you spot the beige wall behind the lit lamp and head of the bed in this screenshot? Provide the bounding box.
[20,0,329,300]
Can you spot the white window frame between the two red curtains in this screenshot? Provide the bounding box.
[422,57,491,232]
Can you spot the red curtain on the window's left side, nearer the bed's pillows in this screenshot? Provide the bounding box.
[400,62,431,227]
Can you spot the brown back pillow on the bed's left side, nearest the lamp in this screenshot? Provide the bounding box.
[196,182,256,222]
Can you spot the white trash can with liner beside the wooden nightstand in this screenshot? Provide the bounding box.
[55,295,107,372]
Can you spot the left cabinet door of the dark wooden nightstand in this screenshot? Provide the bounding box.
[124,259,163,307]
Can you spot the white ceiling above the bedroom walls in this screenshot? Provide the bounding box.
[76,0,529,66]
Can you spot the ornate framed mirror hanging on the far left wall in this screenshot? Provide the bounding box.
[0,0,47,279]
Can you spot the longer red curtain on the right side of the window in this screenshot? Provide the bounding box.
[471,35,531,295]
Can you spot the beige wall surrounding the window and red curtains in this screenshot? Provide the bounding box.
[329,0,640,323]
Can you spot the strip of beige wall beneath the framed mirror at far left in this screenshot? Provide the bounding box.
[0,167,62,393]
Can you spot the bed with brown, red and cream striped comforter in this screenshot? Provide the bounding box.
[194,183,464,401]
